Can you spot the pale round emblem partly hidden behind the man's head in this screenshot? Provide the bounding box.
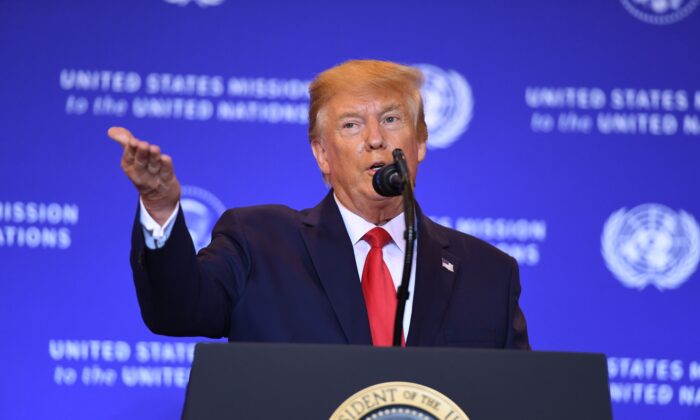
[415,64,474,149]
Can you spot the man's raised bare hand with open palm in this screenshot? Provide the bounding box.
[107,127,180,225]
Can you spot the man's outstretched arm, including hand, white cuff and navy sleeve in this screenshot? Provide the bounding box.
[108,127,235,337]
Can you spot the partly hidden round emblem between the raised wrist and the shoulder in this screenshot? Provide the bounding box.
[180,186,226,251]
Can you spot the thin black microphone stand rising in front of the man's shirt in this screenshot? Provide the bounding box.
[393,149,416,347]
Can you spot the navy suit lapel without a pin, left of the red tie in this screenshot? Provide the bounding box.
[301,190,372,344]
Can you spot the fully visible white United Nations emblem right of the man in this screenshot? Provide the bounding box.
[601,204,700,290]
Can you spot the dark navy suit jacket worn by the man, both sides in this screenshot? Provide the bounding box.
[131,192,529,349]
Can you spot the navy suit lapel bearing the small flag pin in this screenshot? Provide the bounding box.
[406,208,460,346]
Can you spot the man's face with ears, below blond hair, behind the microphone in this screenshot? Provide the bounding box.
[312,92,426,210]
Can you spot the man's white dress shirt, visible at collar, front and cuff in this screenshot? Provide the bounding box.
[139,194,418,340]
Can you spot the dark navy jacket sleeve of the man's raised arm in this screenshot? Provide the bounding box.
[130,205,250,338]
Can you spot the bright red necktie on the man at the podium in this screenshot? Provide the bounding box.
[362,227,396,346]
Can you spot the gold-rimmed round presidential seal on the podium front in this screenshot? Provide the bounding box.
[330,382,469,420]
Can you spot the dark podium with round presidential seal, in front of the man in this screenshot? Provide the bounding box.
[182,343,612,420]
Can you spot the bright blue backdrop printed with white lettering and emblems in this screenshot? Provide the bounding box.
[0,0,700,419]
